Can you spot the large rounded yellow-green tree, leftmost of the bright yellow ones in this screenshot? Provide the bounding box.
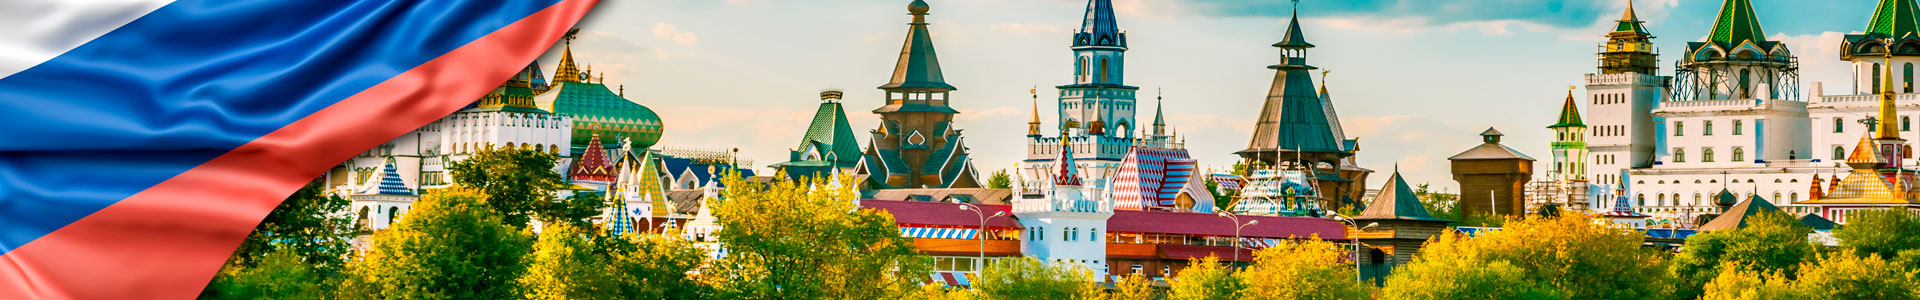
[342,188,532,300]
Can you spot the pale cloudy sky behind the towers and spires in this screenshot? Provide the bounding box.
[541,0,1874,190]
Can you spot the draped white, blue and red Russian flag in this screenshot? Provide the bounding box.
[0,0,597,300]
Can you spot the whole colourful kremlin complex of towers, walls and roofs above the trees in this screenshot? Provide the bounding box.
[324,0,1920,287]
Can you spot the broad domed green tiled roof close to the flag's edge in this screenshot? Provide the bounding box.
[536,81,662,148]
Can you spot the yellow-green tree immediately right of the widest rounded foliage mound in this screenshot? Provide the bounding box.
[1672,212,1814,298]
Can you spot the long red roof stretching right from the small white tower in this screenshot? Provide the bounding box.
[1106,210,1346,240]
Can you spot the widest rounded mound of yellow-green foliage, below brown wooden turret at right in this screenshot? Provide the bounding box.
[1382,212,1670,298]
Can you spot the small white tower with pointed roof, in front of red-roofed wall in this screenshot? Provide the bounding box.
[1014,135,1114,273]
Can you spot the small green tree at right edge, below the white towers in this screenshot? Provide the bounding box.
[1834,210,1920,258]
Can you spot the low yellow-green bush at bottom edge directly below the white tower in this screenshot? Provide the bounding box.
[975,258,1104,300]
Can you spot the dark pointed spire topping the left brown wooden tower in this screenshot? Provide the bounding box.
[879,0,954,90]
